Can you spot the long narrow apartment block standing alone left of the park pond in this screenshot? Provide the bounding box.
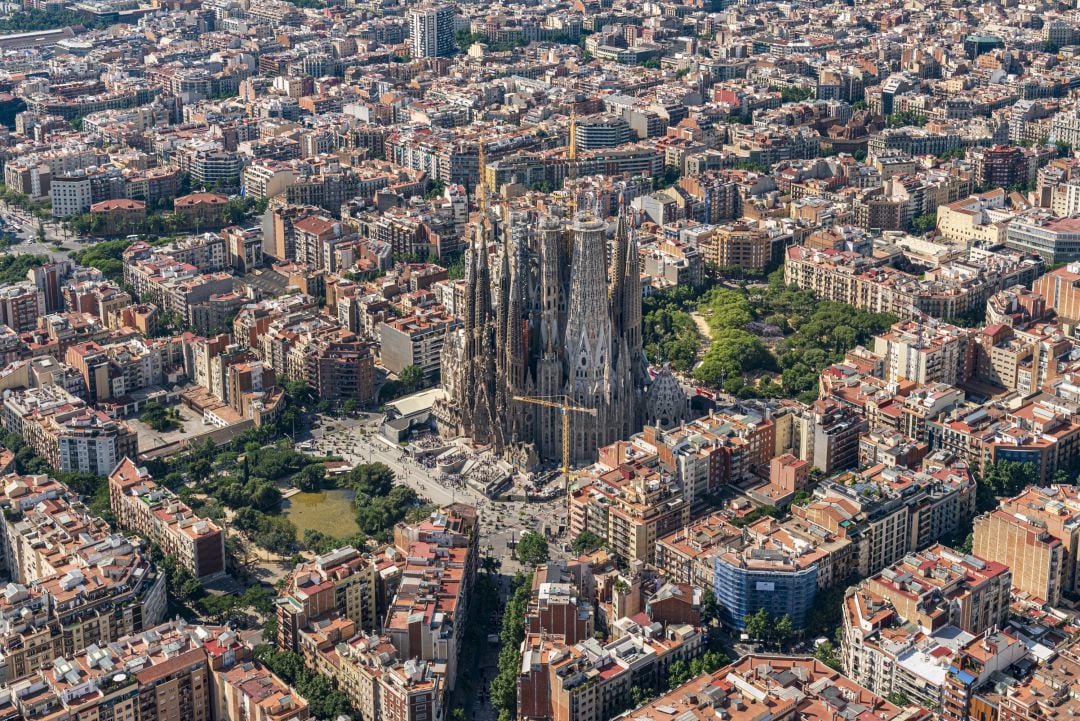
[109,458,225,579]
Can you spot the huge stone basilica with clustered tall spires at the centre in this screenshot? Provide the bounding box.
[435,185,680,465]
